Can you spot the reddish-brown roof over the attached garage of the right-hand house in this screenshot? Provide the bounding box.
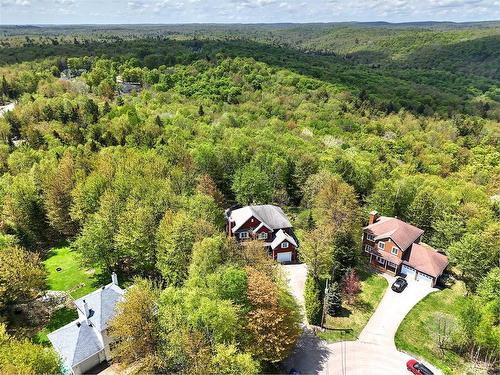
[403,243,448,278]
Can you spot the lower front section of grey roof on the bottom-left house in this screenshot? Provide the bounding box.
[48,320,103,367]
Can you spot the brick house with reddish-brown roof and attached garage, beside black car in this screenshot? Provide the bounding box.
[363,211,448,286]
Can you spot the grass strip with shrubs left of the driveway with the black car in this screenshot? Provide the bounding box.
[320,271,388,342]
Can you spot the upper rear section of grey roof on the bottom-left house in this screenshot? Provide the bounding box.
[75,283,125,332]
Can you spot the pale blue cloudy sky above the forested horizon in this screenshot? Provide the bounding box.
[0,0,500,24]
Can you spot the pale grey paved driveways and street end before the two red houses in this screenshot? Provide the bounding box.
[284,265,441,375]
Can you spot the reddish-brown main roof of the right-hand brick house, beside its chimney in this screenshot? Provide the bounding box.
[363,216,424,251]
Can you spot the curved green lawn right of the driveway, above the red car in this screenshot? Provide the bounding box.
[395,282,476,375]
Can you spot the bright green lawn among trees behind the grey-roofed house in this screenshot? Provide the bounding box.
[43,246,97,298]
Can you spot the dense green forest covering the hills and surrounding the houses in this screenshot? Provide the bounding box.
[0,23,500,374]
